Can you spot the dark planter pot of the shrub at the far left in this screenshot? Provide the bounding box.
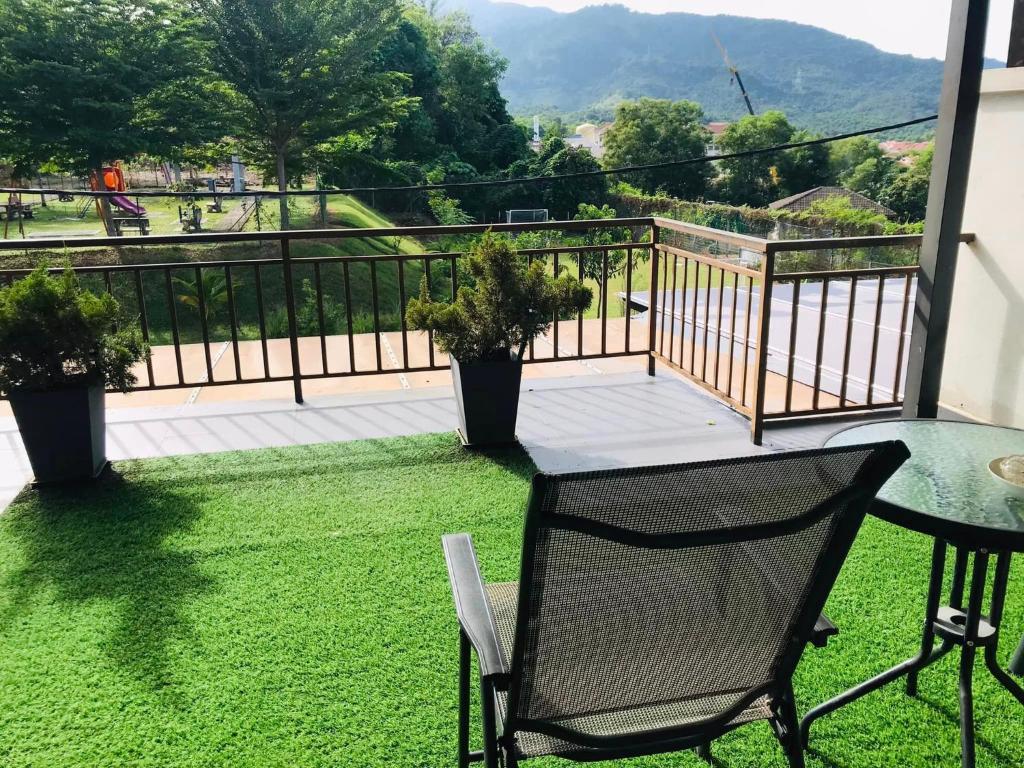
[9,384,106,484]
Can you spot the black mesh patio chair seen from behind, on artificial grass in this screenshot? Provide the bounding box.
[443,442,908,768]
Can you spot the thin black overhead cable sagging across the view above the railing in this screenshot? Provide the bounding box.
[0,115,939,198]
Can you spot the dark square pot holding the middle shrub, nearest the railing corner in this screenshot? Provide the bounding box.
[452,356,522,447]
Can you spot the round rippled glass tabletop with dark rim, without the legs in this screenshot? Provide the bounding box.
[825,419,1024,552]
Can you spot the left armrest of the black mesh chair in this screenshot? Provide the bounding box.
[441,534,508,679]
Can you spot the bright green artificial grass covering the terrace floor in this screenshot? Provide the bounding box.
[0,435,1024,768]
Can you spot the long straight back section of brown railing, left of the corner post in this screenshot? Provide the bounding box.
[0,219,651,402]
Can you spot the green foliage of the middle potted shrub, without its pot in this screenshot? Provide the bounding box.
[406,232,594,362]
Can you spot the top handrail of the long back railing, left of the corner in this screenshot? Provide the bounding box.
[0,217,654,251]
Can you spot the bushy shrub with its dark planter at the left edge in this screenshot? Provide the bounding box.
[0,265,150,483]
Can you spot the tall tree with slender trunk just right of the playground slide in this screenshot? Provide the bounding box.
[195,0,410,229]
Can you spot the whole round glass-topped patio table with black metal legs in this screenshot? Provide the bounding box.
[801,419,1024,768]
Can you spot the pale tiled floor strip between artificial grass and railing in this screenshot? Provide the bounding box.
[0,370,843,510]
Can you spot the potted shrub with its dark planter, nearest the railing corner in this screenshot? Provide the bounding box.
[406,232,593,446]
